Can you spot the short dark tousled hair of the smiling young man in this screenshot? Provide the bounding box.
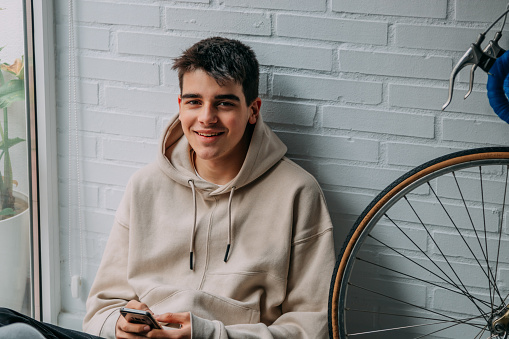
[172,37,260,105]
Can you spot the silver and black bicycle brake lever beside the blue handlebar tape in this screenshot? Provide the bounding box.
[442,4,509,111]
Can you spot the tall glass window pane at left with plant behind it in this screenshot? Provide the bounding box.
[0,0,32,315]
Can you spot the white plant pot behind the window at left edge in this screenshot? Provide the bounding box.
[0,192,30,312]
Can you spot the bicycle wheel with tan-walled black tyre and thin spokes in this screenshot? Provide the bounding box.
[329,147,509,339]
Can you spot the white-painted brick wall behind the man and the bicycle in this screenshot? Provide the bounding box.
[51,0,509,327]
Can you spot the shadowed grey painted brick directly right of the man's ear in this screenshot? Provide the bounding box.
[261,100,316,126]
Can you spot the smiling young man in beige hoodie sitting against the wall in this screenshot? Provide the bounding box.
[84,37,334,338]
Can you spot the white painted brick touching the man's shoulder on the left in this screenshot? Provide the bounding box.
[82,161,140,187]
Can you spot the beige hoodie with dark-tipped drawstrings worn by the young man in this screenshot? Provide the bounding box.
[83,117,335,338]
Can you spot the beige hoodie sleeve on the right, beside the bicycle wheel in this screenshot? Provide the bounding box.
[192,184,335,339]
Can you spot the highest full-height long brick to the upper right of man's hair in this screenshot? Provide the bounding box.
[276,14,387,45]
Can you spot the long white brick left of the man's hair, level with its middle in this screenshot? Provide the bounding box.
[78,57,159,85]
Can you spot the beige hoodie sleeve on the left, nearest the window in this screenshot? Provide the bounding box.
[83,179,137,339]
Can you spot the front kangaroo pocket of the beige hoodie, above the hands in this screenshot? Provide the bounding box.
[145,287,260,325]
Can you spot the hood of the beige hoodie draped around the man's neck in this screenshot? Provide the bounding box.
[157,115,287,195]
